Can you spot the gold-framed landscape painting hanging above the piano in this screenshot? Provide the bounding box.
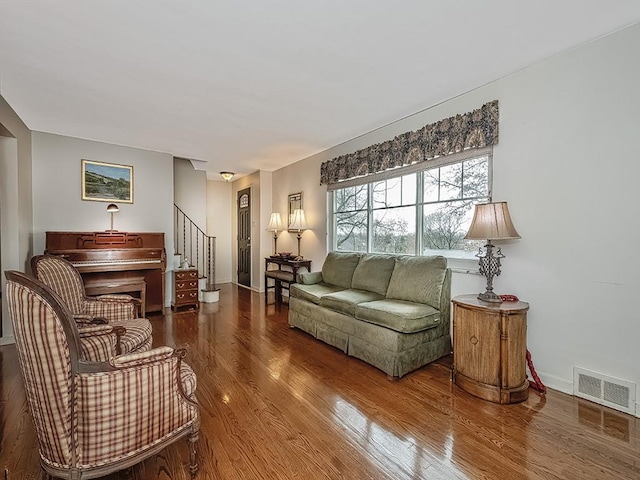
[81,159,133,203]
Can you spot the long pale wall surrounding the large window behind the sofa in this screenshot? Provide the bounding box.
[273,20,640,411]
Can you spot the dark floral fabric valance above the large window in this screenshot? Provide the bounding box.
[320,100,498,185]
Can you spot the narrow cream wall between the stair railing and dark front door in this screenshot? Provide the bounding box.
[207,180,232,283]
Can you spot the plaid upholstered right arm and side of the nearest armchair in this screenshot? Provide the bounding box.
[73,348,200,465]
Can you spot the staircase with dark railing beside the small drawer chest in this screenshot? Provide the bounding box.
[173,204,219,303]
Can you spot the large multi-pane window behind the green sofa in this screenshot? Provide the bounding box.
[329,152,491,258]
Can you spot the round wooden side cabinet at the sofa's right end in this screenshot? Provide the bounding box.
[452,295,529,404]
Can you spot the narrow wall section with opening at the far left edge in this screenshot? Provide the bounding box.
[0,96,33,345]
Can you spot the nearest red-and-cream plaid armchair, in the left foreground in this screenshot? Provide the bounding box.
[6,271,200,480]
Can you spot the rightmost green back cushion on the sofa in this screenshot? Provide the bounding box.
[387,255,447,308]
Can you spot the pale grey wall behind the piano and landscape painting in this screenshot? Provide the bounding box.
[32,132,174,306]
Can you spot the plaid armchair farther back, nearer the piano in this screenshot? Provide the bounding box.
[31,255,152,362]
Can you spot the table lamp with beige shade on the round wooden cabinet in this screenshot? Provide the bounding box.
[464,202,520,303]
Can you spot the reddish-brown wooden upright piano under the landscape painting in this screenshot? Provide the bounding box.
[45,230,167,312]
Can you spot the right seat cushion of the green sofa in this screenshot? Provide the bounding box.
[355,299,440,333]
